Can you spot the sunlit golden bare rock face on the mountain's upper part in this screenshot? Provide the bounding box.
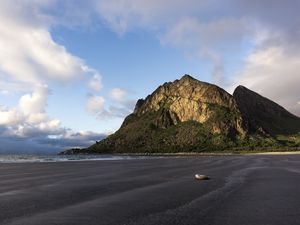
[134,74,244,133]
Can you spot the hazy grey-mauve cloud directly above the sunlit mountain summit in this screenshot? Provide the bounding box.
[161,17,246,52]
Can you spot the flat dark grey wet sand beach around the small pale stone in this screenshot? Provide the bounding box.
[0,155,300,225]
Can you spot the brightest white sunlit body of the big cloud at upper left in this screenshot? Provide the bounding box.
[0,8,84,83]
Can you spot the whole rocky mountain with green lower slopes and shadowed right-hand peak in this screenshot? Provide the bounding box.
[63,75,300,154]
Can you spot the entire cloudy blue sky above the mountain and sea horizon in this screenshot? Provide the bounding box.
[0,0,300,153]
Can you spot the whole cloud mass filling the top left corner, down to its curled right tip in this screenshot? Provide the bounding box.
[0,0,102,92]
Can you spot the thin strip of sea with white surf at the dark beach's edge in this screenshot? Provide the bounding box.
[0,154,145,163]
